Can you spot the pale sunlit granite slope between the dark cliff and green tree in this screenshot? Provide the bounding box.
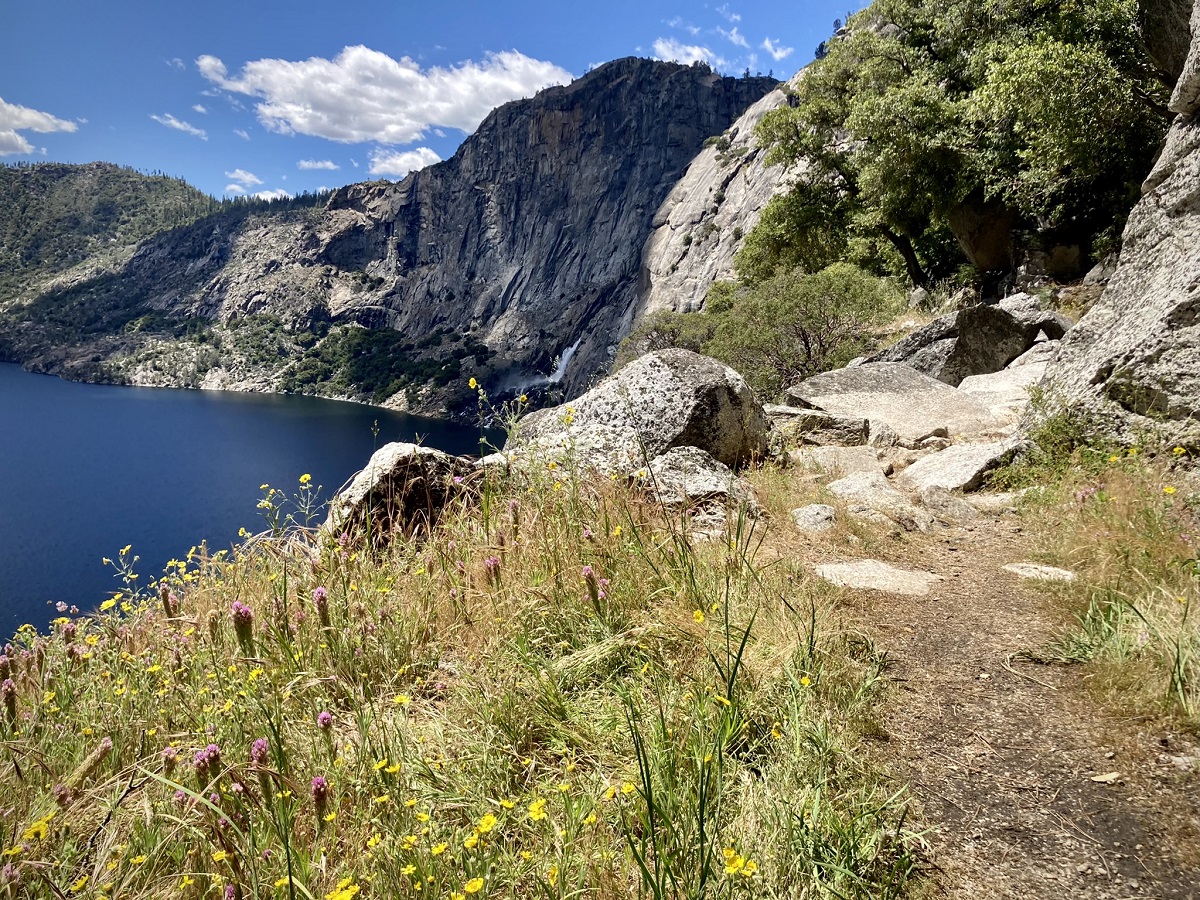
[637,76,799,318]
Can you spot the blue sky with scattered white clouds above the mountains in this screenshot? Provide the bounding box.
[0,0,860,197]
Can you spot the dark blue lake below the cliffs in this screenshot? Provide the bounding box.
[0,364,492,642]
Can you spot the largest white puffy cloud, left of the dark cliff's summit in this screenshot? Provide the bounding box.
[196,46,571,144]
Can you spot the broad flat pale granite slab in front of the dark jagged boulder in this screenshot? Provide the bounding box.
[787,362,1009,444]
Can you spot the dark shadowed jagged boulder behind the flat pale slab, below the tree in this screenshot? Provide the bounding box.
[866,294,1070,385]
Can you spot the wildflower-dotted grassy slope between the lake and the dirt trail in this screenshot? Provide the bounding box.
[0,460,920,900]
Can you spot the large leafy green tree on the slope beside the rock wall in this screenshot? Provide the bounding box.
[753,0,1166,284]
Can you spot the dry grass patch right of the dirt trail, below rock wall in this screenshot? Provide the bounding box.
[1000,436,1200,730]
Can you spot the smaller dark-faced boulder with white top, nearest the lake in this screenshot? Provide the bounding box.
[322,442,475,545]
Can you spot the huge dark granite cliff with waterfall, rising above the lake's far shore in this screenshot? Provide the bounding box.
[0,59,776,413]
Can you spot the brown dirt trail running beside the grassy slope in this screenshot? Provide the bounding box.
[838,516,1200,899]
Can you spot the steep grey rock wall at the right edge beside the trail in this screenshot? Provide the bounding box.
[1044,4,1200,448]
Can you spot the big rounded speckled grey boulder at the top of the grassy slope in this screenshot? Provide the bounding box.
[506,349,769,474]
